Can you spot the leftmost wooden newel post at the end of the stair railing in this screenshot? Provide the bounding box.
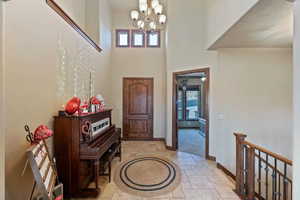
[234,133,247,197]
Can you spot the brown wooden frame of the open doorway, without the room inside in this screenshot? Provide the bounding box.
[172,67,214,160]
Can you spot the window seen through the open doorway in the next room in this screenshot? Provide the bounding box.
[177,88,201,121]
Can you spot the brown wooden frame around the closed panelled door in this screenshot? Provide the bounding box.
[122,77,154,141]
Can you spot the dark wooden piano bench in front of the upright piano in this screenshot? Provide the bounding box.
[100,143,121,183]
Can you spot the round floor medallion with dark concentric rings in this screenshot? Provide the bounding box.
[114,154,181,198]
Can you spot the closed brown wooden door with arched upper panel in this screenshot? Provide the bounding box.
[123,78,153,140]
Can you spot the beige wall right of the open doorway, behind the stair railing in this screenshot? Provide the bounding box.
[211,49,293,172]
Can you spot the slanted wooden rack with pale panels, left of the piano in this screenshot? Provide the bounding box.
[27,140,63,200]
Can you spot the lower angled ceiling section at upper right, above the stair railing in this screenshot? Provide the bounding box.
[209,0,293,50]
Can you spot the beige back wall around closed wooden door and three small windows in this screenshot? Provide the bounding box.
[112,13,166,138]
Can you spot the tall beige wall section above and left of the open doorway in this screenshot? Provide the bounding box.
[166,0,217,147]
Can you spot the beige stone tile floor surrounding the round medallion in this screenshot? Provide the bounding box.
[77,141,239,200]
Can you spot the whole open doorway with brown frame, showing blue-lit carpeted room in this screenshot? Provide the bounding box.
[172,68,210,159]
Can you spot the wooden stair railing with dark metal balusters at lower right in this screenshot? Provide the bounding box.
[234,133,293,200]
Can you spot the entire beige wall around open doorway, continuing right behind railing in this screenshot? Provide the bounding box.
[166,0,292,172]
